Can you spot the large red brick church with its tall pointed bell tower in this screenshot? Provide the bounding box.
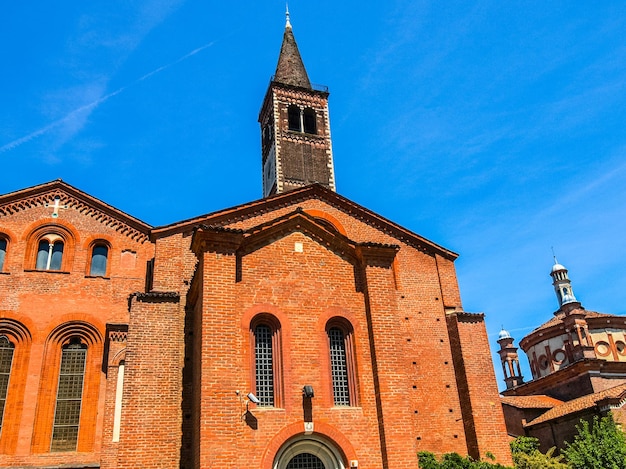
[0,12,510,469]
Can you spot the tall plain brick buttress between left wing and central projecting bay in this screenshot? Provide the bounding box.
[114,294,184,469]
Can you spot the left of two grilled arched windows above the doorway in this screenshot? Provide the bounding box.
[251,315,282,407]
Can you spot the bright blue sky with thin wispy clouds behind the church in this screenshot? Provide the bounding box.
[0,0,626,385]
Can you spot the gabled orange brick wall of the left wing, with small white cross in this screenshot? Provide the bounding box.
[0,195,154,467]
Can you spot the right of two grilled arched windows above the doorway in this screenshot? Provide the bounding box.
[326,319,357,406]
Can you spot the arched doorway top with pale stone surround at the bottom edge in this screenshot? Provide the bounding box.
[273,435,346,469]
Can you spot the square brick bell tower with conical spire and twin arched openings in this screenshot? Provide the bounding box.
[259,11,335,197]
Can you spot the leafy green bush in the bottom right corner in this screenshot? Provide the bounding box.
[562,414,626,469]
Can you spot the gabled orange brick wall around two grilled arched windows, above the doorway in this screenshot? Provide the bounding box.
[194,233,382,467]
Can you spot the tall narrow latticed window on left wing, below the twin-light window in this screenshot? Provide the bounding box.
[50,338,87,451]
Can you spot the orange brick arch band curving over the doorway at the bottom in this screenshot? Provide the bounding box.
[260,421,358,469]
